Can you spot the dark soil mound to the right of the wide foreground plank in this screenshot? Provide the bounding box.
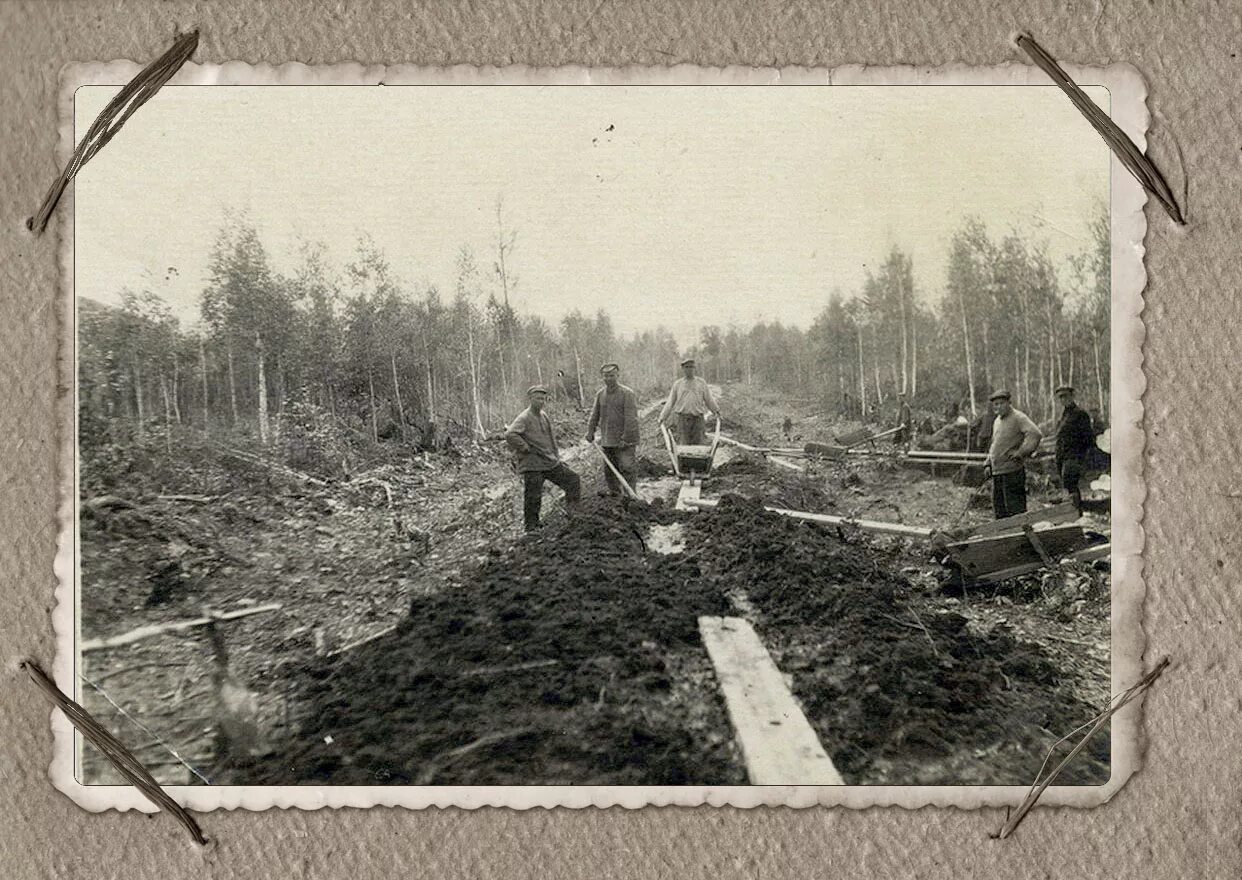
[688,496,1108,784]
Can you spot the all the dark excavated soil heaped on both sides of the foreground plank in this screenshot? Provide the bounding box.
[246,496,1108,784]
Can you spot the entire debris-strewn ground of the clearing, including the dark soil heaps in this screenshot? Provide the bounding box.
[82,386,1109,784]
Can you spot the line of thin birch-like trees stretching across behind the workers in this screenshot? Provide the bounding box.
[78,210,1110,448]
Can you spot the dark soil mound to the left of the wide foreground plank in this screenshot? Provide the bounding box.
[247,499,744,784]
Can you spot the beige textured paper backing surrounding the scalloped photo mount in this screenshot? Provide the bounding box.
[0,0,1242,879]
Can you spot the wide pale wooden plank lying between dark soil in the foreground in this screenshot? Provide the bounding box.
[698,617,845,786]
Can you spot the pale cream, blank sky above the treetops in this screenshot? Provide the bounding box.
[75,86,1109,341]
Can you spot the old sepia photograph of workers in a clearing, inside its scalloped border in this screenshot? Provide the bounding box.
[67,84,1117,787]
